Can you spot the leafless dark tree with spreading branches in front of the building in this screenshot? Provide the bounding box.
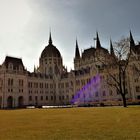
[98,38,131,107]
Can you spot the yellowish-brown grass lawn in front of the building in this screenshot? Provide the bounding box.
[0,106,140,140]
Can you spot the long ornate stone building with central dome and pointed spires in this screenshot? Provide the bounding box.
[0,33,140,108]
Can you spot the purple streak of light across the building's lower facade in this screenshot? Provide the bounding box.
[71,75,100,105]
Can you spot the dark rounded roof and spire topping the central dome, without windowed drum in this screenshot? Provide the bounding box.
[41,34,61,58]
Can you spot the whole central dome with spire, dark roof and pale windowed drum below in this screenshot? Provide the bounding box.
[39,33,63,75]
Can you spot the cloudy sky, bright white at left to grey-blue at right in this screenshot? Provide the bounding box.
[0,0,140,71]
